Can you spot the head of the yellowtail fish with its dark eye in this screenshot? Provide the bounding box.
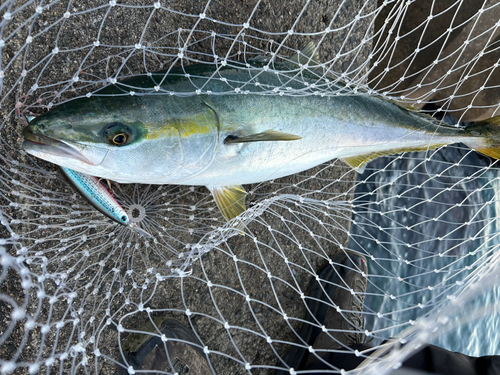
[23,98,220,183]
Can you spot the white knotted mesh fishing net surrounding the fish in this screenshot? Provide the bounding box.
[0,0,500,374]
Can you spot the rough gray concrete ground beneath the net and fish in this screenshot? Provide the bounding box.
[0,0,375,374]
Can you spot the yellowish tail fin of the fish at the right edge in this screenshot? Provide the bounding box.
[466,116,500,159]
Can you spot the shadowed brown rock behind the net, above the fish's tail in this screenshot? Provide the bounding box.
[370,0,500,121]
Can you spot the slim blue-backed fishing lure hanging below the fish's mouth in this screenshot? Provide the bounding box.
[60,167,152,237]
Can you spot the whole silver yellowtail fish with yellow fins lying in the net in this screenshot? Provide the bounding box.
[23,44,500,225]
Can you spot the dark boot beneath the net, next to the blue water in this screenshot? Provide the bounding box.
[276,252,368,375]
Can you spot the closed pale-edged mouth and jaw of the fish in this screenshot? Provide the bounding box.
[23,126,107,165]
